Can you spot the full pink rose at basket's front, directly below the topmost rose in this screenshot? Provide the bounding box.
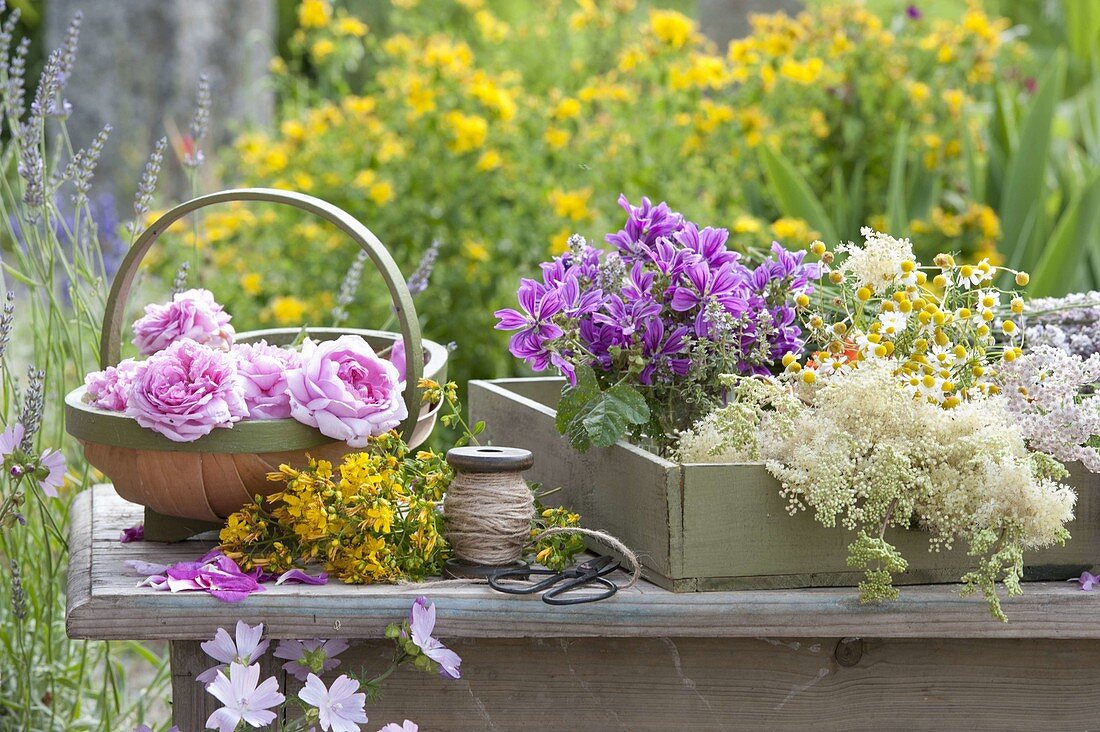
[127,340,249,443]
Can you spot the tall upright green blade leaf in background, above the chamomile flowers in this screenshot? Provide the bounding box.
[999,53,1066,269]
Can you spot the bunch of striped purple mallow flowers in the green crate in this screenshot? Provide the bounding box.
[496,196,821,400]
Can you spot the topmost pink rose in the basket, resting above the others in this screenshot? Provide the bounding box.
[133,289,237,356]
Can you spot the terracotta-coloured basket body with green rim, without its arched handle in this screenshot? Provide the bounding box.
[65,328,447,522]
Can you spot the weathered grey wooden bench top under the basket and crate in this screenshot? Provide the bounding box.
[67,485,1100,640]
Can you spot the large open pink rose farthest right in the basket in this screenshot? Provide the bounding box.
[286,336,408,447]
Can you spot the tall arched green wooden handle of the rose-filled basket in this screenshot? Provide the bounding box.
[99,188,424,439]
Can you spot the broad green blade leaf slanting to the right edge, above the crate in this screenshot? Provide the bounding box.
[1027,172,1100,297]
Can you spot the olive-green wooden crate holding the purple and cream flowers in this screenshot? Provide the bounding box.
[469,379,1100,592]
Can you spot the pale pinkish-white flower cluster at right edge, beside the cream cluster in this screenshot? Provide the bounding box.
[999,346,1100,472]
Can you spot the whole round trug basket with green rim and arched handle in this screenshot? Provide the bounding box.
[65,188,447,538]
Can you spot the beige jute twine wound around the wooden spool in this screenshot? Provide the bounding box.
[443,472,535,567]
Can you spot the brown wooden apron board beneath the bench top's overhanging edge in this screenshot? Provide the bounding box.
[174,636,1100,731]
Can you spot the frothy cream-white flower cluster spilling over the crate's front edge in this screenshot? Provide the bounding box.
[758,360,1076,619]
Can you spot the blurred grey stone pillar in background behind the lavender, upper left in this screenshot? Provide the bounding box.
[45,0,276,200]
